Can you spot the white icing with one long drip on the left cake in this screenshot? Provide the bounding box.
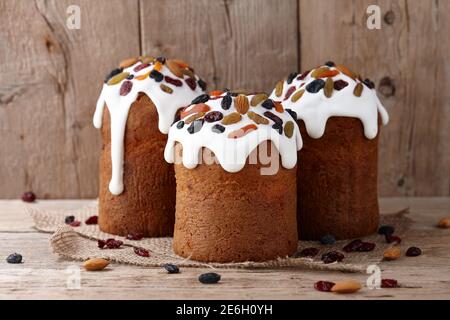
[93,62,203,195]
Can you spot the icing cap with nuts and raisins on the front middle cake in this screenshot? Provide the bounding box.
[165,89,301,172]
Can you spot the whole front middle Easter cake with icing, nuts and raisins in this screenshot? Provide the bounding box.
[164,91,302,262]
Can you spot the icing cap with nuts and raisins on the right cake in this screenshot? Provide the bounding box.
[271,61,389,139]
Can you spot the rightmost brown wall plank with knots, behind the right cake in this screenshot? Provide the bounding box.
[299,0,450,196]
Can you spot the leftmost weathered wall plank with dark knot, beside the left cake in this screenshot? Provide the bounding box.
[0,0,139,198]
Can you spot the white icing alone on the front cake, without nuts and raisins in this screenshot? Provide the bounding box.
[164,94,302,172]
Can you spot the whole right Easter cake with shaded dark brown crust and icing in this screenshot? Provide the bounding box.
[271,62,389,240]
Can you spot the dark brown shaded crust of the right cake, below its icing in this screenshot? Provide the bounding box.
[297,117,379,240]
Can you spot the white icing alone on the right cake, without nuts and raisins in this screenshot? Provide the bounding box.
[270,67,389,139]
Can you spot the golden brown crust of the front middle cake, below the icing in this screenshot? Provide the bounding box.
[174,145,298,262]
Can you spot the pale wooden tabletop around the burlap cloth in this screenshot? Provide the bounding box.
[0,198,450,299]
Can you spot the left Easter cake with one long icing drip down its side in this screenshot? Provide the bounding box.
[93,56,206,236]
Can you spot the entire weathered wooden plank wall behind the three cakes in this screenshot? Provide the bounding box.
[0,0,450,198]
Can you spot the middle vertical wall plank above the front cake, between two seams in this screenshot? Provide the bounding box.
[141,0,298,91]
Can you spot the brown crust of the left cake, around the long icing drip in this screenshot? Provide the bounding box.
[99,94,175,237]
